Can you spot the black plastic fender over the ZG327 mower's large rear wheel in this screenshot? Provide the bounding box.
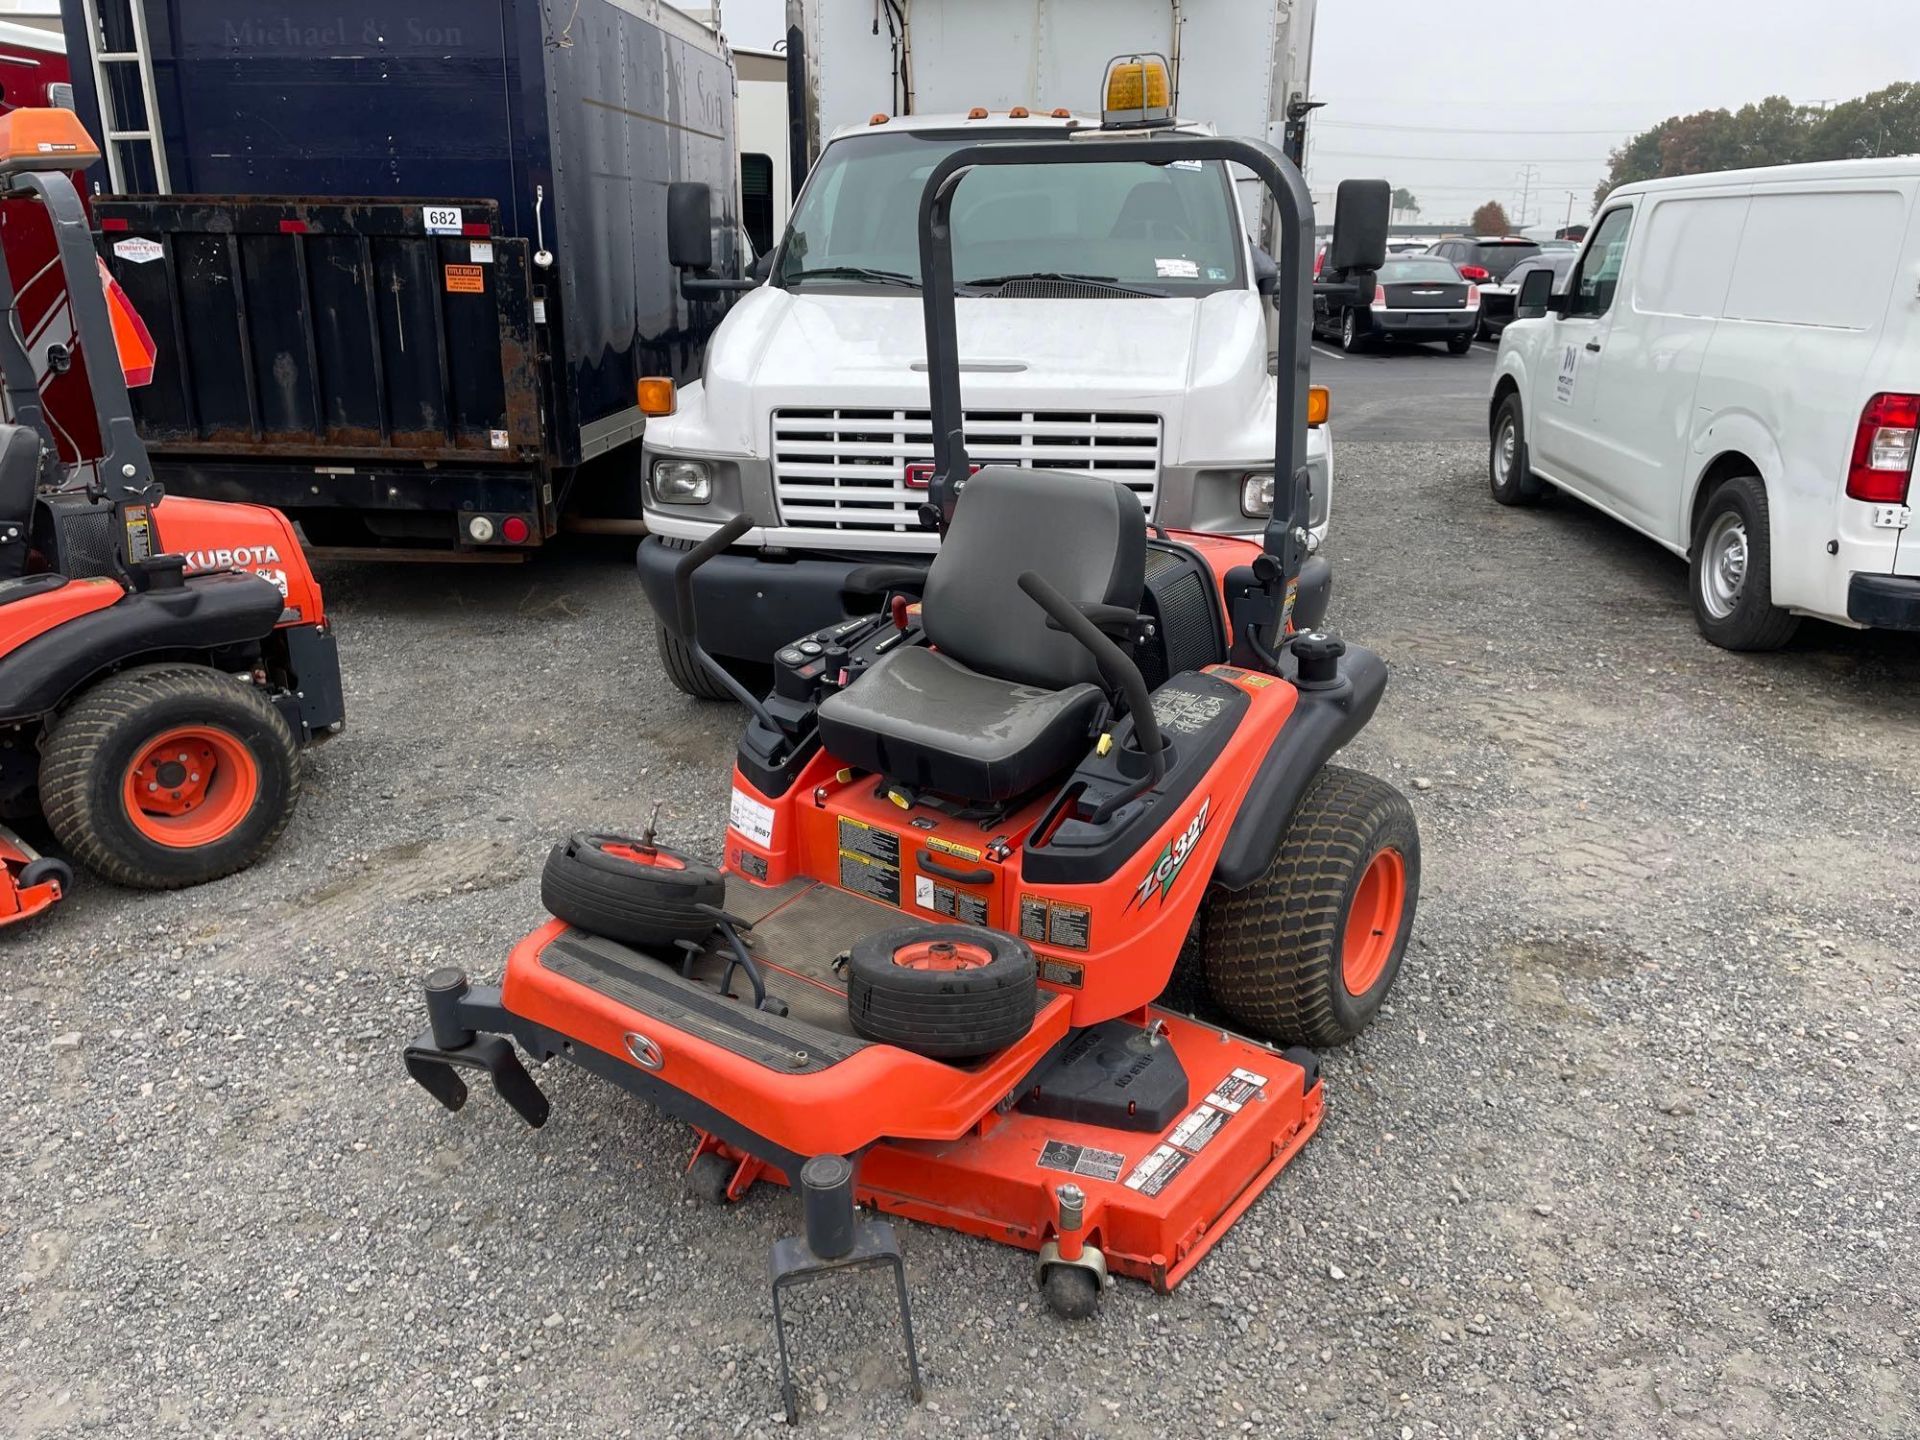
[1213,645,1386,891]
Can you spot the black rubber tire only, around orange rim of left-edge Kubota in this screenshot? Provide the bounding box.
[40,662,300,891]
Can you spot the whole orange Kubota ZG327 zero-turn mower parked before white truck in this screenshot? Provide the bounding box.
[407,132,1419,1413]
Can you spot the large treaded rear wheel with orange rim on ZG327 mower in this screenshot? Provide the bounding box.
[1206,766,1421,1048]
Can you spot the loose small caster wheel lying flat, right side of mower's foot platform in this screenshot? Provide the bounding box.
[847,925,1039,1060]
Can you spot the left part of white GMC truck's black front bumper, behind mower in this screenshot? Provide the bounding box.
[636,536,898,662]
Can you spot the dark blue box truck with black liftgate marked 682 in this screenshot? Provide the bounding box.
[63,0,745,555]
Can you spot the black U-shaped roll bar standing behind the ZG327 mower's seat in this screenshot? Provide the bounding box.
[920,131,1313,648]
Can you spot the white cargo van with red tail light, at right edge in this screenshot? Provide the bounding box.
[1488,156,1920,649]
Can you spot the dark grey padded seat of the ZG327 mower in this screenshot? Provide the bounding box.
[820,467,1146,803]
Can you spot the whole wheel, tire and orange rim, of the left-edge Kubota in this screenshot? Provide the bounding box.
[40,664,300,891]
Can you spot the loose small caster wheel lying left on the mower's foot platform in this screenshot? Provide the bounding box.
[540,831,726,948]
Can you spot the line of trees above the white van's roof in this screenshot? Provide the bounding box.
[1594,83,1920,207]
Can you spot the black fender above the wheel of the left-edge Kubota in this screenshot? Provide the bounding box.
[0,570,284,722]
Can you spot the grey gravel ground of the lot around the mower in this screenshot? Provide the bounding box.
[0,444,1920,1440]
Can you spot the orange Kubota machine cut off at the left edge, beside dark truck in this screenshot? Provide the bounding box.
[0,109,342,925]
